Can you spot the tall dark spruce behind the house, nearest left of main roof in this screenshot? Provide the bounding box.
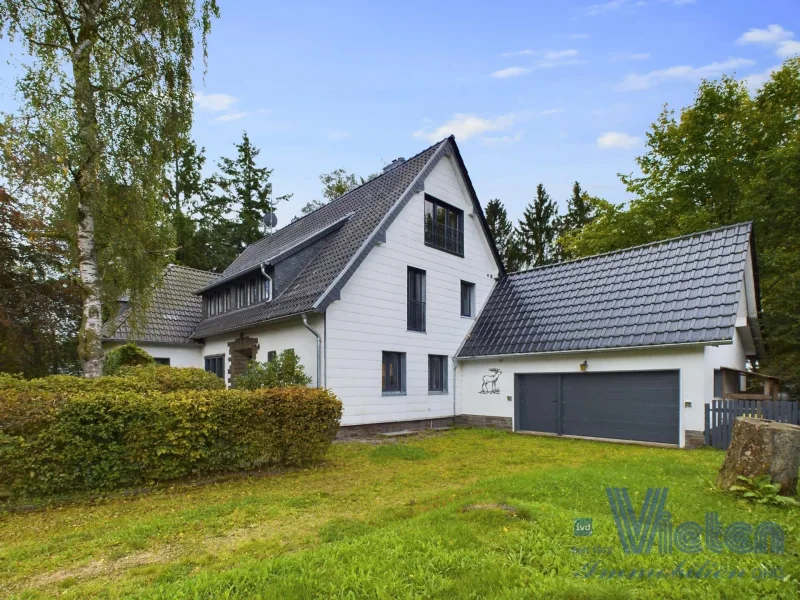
[208,132,292,253]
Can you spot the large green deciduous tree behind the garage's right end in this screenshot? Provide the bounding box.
[571,58,800,386]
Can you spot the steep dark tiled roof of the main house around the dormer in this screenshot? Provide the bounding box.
[192,137,499,339]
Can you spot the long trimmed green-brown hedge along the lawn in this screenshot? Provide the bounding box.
[0,378,342,497]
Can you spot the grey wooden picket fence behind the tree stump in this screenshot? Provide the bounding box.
[705,400,800,450]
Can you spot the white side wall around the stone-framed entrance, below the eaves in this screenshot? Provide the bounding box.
[201,314,325,386]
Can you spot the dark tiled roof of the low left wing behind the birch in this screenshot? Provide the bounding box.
[103,265,219,344]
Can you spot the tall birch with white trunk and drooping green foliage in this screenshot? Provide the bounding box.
[0,0,218,377]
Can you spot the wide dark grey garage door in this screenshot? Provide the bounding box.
[514,371,680,444]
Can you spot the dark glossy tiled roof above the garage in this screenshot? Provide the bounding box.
[459,223,751,357]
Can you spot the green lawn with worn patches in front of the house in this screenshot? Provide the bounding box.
[0,430,800,599]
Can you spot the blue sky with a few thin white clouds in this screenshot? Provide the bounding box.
[0,0,800,224]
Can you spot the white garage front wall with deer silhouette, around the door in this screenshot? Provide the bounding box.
[457,346,707,446]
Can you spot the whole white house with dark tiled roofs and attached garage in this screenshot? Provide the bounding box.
[104,137,759,446]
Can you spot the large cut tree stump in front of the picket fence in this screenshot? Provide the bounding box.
[717,417,800,496]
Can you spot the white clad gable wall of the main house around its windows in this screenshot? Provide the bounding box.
[326,157,498,425]
